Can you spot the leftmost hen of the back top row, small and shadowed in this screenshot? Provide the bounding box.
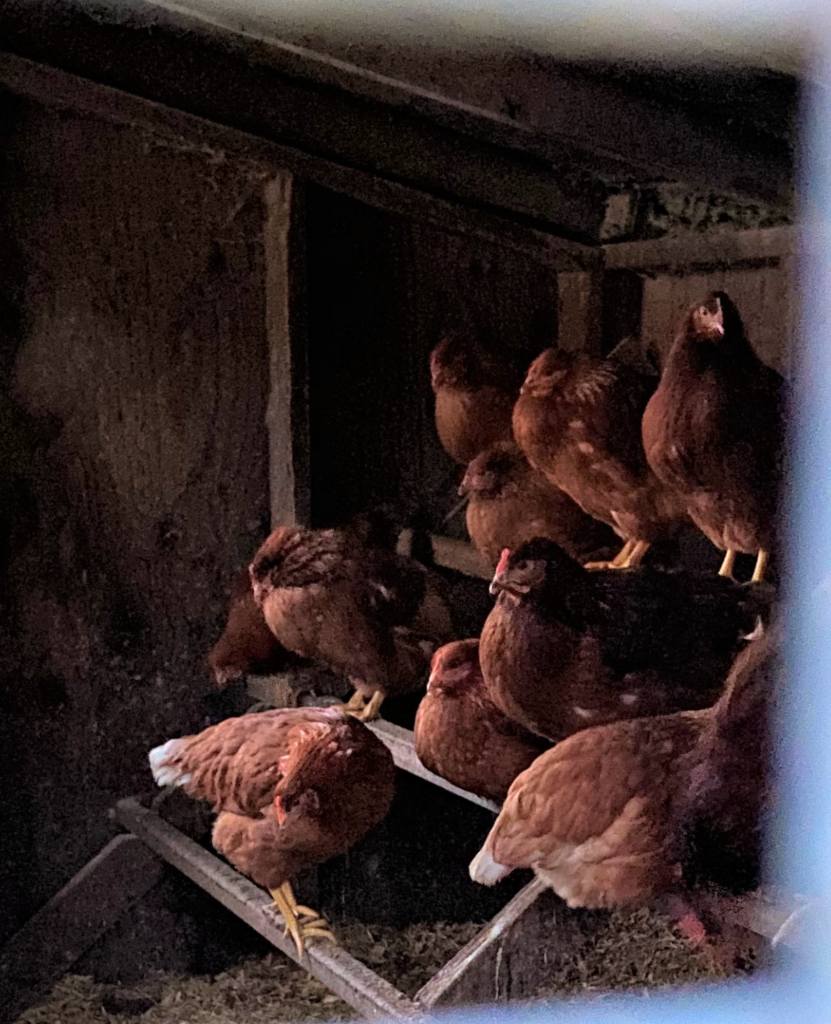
[430,331,522,466]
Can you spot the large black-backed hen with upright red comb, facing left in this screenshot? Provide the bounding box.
[479,538,770,741]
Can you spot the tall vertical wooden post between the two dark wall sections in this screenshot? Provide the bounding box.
[264,171,311,527]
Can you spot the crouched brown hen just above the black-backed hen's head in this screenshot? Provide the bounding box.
[458,441,619,568]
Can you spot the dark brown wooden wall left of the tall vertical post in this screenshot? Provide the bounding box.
[0,95,269,931]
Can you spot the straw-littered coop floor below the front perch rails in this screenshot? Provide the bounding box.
[16,910,753,1024]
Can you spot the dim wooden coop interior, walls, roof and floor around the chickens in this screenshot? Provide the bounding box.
[0,0,800,1024]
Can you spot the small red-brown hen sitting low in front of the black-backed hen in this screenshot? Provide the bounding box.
[414,640,549,804]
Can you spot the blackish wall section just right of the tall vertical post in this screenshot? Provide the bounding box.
[307,188,558,536]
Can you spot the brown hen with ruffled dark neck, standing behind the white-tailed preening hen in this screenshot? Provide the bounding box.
[250,526,452,721]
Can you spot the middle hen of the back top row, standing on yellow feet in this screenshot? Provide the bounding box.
[513,348,687,568]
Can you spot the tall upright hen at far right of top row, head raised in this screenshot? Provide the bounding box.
[643,292,785,581]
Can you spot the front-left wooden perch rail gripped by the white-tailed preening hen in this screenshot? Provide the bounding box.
[116,798,419,1020]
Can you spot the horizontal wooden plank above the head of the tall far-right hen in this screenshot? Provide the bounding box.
[603,226,800,273]
